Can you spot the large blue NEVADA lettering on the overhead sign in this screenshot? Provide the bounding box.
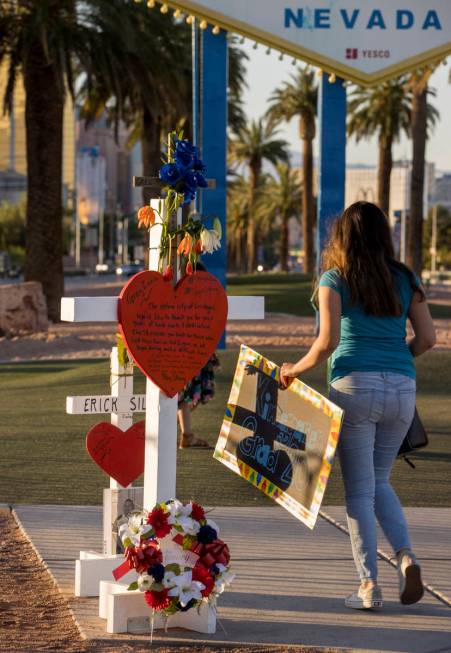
[284,7,442,30]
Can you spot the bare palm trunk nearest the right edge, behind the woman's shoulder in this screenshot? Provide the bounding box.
[406,86,427,275]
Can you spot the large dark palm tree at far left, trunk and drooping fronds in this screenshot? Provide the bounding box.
[0,0,141,321]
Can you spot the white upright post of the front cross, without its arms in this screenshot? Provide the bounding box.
[144,200,182,510]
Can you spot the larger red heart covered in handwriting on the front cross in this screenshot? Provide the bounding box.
[119,270,227,397]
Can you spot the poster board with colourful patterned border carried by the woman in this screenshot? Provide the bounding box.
[214,345,343,528]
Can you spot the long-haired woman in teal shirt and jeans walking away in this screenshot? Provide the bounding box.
[281,202,435,609]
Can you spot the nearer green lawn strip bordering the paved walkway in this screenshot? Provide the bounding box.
[0,348,451,506]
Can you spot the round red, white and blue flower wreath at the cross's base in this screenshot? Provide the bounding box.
[113,499,234,618]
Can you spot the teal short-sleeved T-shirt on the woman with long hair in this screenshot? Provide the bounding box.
[319,269,420,382]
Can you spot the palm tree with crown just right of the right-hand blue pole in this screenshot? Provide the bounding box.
[348,77,412,214]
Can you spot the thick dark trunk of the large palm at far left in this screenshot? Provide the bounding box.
[24,37,64,322]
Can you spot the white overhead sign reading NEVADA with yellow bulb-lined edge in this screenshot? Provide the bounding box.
[164,0,451,85]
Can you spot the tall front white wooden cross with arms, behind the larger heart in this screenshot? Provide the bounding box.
[61,177,264,508]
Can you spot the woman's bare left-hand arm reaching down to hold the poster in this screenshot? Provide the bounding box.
[280,286,341,388]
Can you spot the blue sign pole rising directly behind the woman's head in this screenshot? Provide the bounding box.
[316,73,346,274]
